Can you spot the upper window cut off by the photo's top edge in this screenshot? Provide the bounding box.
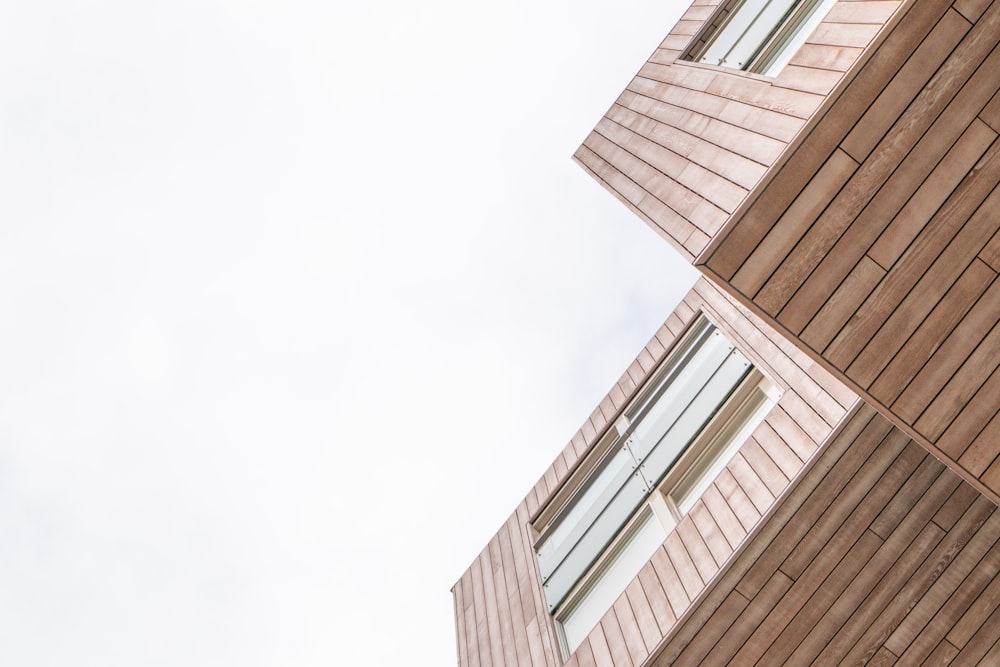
[688,0,835,76]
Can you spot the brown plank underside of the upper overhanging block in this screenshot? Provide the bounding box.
[696,0,1000,500]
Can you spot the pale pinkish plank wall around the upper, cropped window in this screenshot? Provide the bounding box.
[574,0,900,261]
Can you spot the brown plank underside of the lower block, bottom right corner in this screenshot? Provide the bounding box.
[645,405,1000,667]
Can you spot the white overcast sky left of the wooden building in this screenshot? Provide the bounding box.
[0,0,692,667]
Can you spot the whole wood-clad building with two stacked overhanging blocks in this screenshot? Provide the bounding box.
[453,0,1000,667]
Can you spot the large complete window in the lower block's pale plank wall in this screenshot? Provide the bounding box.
[535,317,776,654]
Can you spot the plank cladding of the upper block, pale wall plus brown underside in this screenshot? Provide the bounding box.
[575,0,1000,501]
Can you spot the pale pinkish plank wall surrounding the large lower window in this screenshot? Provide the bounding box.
[452,280,856,667]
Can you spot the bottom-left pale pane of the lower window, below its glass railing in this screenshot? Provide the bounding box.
[561,510,667,652]
